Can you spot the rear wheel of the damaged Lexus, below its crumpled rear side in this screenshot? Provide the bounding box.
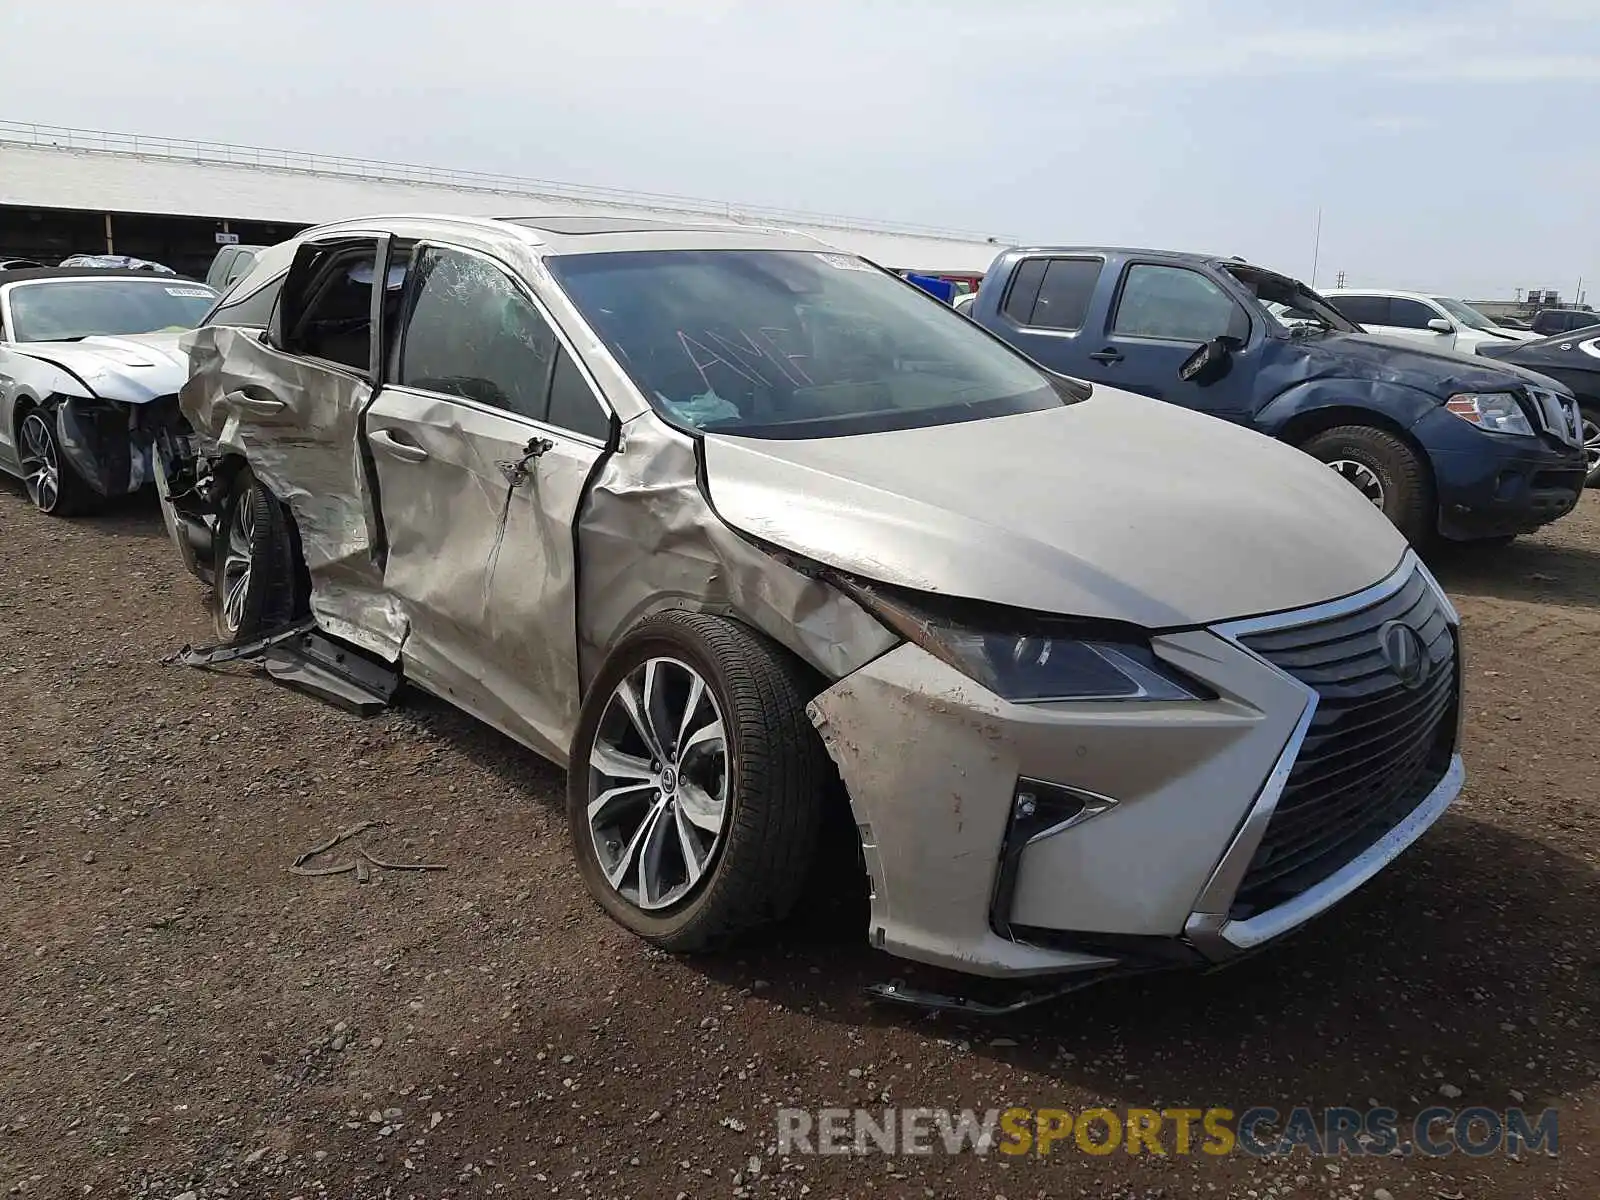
[211,467,307,643]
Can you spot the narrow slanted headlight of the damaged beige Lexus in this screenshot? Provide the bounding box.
[848,582,1211,704]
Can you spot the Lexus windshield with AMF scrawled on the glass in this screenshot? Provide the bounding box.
[547,250,1066,438]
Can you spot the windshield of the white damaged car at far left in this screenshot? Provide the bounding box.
[10,278,216,342]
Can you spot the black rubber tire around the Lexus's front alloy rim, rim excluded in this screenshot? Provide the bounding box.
[566,613,837,954]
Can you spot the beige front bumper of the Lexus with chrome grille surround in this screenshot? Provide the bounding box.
[811,550,1462,978]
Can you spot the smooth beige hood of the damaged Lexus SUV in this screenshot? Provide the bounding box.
[704,387,1406,629]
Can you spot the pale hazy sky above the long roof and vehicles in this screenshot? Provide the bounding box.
[0,0,1600,299]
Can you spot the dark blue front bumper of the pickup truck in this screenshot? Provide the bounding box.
[1411,408,1587,541]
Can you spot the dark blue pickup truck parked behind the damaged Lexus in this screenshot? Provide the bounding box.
[968,248,1586,544]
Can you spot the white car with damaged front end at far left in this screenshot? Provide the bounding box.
[0,267,216,517]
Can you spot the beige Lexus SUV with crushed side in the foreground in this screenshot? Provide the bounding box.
[163,216,1462,978]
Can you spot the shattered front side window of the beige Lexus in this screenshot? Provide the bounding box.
[397,248,557,421]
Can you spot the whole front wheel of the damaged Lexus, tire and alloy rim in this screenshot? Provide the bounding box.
[566,613,832,952]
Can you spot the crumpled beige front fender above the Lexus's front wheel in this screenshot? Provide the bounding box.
[578,414,899,686]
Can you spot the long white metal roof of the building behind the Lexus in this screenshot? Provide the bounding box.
[0,122,1014,274]
